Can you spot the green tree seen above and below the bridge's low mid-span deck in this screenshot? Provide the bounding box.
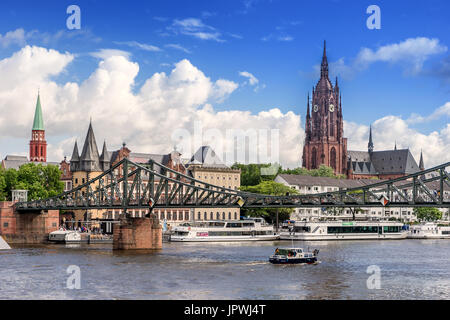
[241,181,298,223]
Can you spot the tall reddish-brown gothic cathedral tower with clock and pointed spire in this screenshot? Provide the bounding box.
[302,42,347,174]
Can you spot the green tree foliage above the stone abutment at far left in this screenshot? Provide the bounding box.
[0,163,64,200]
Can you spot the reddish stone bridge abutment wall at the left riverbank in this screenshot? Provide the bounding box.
[0,201,59,245]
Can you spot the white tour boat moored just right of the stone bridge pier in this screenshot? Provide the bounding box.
[170,218,279,242]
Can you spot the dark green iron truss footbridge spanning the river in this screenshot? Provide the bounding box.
[16,158,450,212]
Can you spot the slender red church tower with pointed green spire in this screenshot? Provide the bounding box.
[30,93,47,162]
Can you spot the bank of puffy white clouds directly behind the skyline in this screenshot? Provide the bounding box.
[0,46,450,168]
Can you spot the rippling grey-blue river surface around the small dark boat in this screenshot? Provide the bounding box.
[0,239,450,300]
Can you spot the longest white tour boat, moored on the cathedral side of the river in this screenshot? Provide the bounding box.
[280,221,407,240]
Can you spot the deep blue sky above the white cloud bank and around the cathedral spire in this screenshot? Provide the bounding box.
[0,0,450,165]
